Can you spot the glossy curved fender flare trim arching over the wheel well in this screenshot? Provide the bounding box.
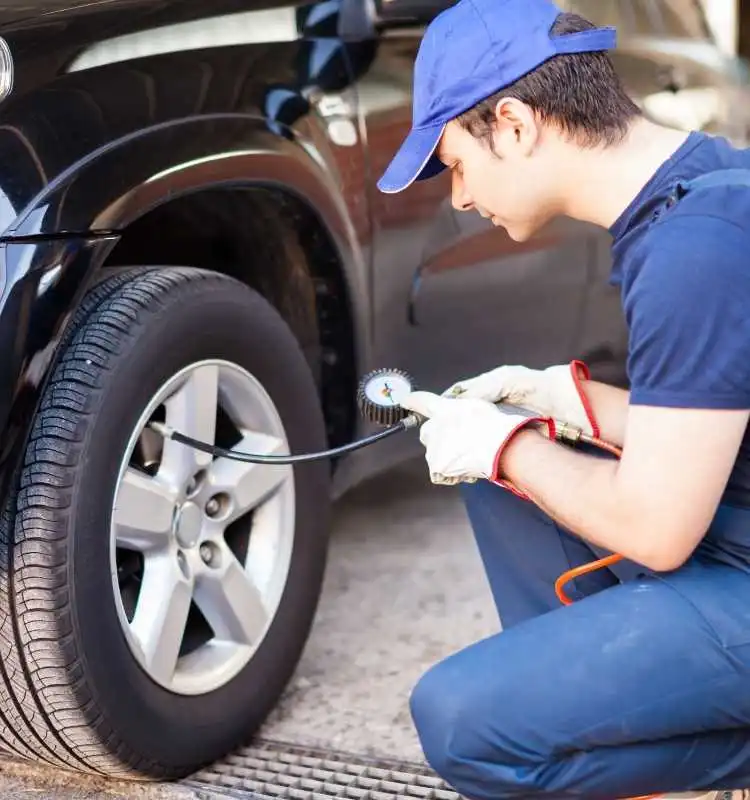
[5,114,365,296]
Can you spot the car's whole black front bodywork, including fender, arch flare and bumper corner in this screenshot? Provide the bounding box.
[0,0,388,494]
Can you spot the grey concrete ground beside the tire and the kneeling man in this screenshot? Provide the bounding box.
[0,459,498,800]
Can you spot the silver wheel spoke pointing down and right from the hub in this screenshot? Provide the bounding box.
[195,546,268,645]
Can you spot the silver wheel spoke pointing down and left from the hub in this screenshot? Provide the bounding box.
[130,553,193,683]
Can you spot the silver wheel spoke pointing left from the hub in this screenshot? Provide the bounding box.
[112,467,175,552]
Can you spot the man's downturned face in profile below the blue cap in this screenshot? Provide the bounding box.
[437,114,558,242]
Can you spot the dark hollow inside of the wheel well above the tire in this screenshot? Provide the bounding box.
[102,184,358,454]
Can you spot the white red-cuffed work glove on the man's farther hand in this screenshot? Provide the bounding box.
[443,361,600,437]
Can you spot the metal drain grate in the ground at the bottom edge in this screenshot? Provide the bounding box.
[183,742,461,800]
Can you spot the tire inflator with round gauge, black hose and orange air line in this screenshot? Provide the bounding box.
[149,369,624,608]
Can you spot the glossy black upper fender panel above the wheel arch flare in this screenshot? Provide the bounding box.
[0,0,370,235]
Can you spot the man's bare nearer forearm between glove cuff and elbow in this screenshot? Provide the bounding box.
[502,429,669,570]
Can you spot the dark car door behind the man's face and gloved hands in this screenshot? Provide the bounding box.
[357,0,592,390]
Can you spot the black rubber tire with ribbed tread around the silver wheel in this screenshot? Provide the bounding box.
[0,268,330,779]
